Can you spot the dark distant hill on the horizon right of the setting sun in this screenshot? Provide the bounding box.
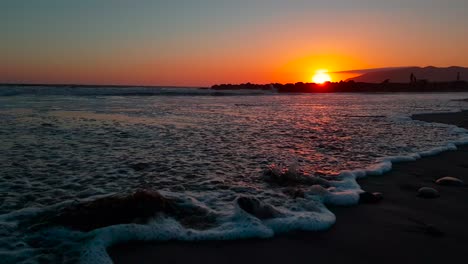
[348,66,468,83]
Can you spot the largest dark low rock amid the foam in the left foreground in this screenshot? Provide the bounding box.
[39,190,216,231]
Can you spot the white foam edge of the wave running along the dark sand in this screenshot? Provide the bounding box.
[0,110,468,263]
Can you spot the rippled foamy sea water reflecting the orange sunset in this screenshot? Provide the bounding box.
[0,87,468,263]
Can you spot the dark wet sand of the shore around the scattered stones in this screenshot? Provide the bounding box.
[108,111,468,264]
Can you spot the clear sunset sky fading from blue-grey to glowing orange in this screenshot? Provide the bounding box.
[0,0,468,86]
